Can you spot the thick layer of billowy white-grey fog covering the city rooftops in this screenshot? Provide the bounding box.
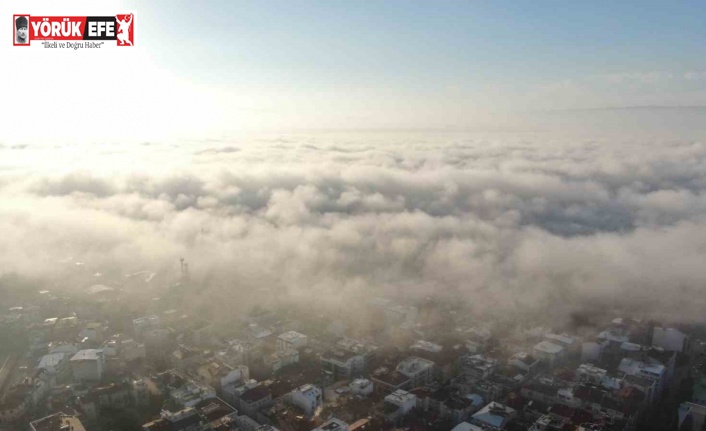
[0,135,706,320]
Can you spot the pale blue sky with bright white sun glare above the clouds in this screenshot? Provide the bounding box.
[0,1,706,138]
